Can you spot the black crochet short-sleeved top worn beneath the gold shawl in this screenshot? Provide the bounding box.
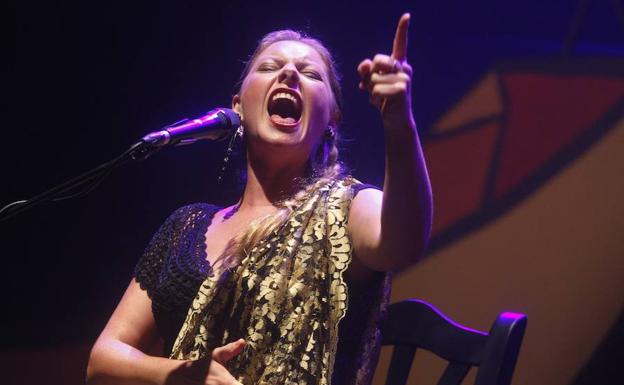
[134,185,384,384]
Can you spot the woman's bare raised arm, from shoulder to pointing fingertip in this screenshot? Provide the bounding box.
[349,14,432,271]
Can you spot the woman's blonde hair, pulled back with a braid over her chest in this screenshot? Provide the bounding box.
[218,30,344,269]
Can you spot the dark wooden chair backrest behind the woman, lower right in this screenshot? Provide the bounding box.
[381,299,527,385]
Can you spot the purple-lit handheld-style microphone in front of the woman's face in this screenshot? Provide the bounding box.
[141,108,240,147]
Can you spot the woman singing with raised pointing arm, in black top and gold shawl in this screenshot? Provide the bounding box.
[87,14,431,385]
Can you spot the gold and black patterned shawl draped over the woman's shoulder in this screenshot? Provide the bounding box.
[171,177,389,385]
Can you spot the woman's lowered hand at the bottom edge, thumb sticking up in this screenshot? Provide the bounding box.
[167,339,246,385]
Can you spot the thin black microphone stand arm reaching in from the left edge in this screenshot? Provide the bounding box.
[0,140,162,222]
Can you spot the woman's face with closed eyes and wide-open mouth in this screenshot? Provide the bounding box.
[233,40,336,160]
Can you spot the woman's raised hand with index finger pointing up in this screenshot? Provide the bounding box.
[357,13,416,130]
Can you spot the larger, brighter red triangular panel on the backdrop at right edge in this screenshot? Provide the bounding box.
[494,73,624,198]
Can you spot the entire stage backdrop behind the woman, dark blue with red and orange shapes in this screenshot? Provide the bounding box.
[0,0,624,385]
